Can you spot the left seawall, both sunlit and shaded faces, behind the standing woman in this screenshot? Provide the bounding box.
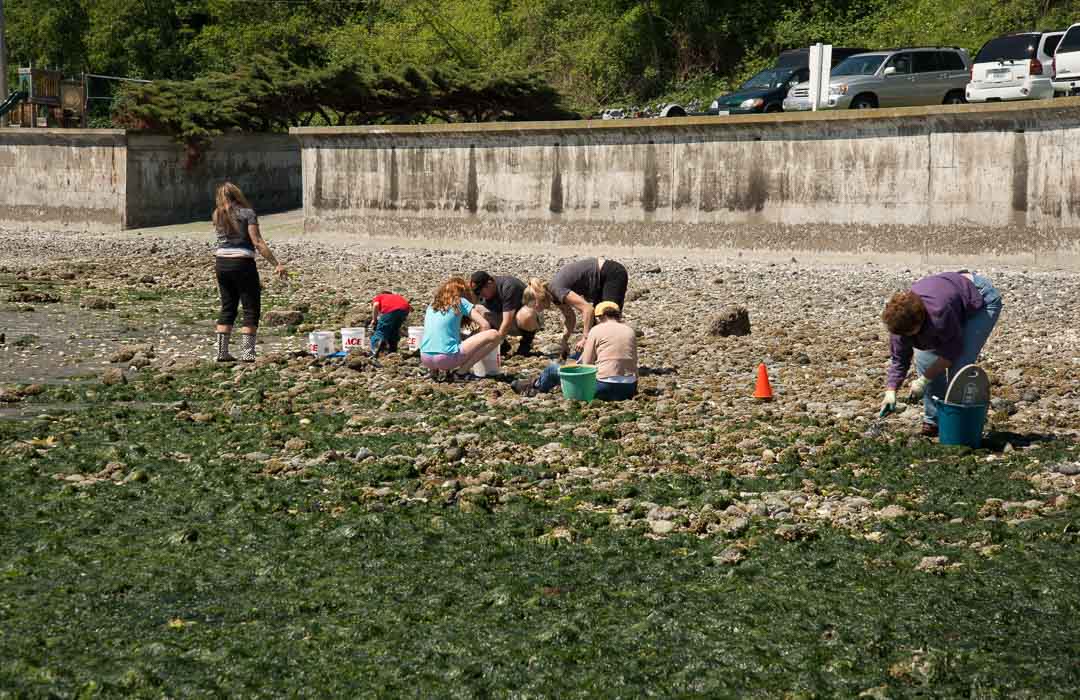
[0,129,301,231]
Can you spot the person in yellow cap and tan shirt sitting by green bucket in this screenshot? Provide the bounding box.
[512,301,637,401]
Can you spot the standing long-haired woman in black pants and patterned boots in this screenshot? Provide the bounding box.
[214,183,285,362]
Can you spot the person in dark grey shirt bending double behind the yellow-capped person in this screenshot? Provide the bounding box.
[551,258,627,356]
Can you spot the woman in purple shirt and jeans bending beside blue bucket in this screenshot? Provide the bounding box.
[881,270,1001,436]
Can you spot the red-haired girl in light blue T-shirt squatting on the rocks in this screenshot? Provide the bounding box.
[420,277,503,380]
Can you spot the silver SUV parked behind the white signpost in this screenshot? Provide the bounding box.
[784,46,971,111]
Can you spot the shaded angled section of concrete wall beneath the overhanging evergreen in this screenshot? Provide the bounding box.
[127,133,300,228]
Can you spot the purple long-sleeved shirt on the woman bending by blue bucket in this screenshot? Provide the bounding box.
[888,272,985,389]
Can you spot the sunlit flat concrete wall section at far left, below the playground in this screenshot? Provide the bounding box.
[0,129,127,231]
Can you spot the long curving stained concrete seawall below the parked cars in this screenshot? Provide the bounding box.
[292,98,1080,259]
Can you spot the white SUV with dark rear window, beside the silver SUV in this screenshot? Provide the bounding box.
[964,31,1065,102]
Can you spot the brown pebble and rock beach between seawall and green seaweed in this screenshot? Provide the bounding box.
[0,224,1080,534]
